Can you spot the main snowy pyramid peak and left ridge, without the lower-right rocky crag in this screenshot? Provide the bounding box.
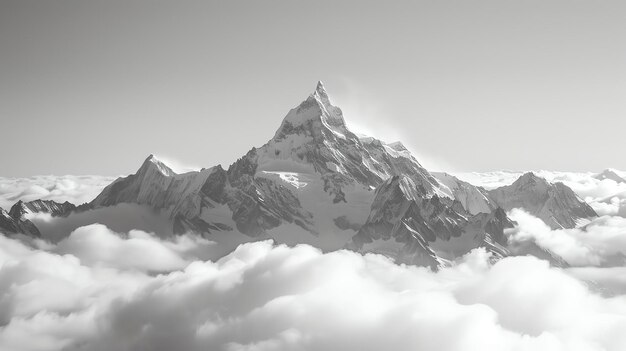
[92,82,452,249]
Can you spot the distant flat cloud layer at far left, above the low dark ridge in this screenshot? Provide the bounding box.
[0,175,115,210]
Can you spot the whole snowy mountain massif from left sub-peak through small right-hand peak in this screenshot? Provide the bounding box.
[49,83,595,267]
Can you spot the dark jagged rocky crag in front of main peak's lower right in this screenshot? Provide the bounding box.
[352,176,513,268]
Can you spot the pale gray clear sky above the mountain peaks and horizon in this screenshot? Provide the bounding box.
[0,0,626,176]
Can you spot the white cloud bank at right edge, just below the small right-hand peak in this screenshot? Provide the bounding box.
[509,209,626,266]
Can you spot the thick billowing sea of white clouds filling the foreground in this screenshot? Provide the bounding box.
[0,225,626,351]
